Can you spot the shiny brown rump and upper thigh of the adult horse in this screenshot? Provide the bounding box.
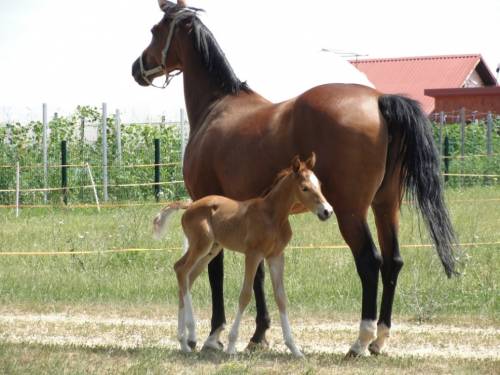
[293,84,389,216]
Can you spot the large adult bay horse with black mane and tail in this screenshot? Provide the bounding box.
[132,0,456,356]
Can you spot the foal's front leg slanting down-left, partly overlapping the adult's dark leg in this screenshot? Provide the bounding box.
[227,253,262,354]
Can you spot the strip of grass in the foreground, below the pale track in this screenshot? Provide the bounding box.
[0,344,500,375]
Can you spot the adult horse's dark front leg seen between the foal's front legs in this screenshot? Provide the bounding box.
[247,261,271,350]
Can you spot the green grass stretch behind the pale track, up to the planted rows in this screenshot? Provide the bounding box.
[0,185,500,321]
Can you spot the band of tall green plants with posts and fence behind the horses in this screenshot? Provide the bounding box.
[0,105,500,212]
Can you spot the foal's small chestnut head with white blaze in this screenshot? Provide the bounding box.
[292,152,333,221]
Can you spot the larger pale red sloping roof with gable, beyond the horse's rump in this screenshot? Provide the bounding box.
[351,54,496,113]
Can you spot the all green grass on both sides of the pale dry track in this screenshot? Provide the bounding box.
[0,185,500,374]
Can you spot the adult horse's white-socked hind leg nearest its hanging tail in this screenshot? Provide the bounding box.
[368,203,403,354]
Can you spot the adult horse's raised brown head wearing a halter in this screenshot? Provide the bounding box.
[132,0,196,87]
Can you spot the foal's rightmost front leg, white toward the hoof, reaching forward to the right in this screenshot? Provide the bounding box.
[267,253,304,358]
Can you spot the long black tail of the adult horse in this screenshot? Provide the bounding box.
[378,95,457,277]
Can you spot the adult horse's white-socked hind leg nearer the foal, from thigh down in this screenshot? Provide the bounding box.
[337,214,381,356]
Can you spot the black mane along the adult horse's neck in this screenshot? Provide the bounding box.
[164,7,250,94]
